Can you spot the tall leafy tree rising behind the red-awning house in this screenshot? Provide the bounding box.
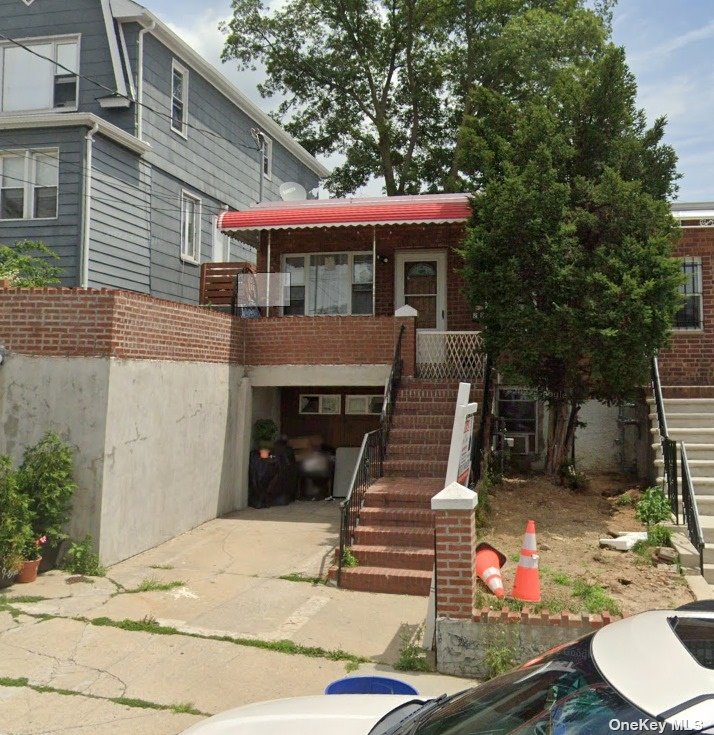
[223,0,614,195]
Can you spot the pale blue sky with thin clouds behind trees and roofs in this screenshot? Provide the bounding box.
[147,0,714,202]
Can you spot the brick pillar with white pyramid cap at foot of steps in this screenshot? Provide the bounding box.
[431,482,478,620]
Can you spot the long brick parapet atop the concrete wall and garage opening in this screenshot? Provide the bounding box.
[0,288,415,368]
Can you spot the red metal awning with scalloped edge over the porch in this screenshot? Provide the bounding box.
[218,194,471,232]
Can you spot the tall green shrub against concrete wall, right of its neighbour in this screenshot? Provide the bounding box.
[17,432,77,546]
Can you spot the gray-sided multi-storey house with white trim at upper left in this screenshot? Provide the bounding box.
[0,0,328,302]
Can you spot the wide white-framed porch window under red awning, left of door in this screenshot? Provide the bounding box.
[283,253,374,316]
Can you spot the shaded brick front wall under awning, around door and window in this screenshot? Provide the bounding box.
[258,224,477,331]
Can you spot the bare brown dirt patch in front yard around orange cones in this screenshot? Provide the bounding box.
[479,475,693,615]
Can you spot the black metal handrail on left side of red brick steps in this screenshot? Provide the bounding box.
[337,324,405,587]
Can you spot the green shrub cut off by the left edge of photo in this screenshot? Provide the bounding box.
[0,457,34,578]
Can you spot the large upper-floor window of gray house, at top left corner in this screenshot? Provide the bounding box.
[0,36,79,112]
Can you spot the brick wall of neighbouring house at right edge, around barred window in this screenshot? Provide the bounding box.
[659,227,714,386]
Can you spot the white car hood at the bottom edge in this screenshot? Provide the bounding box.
[183,694,426,735]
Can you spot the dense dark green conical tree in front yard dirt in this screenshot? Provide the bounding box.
[460,47,681,473]
